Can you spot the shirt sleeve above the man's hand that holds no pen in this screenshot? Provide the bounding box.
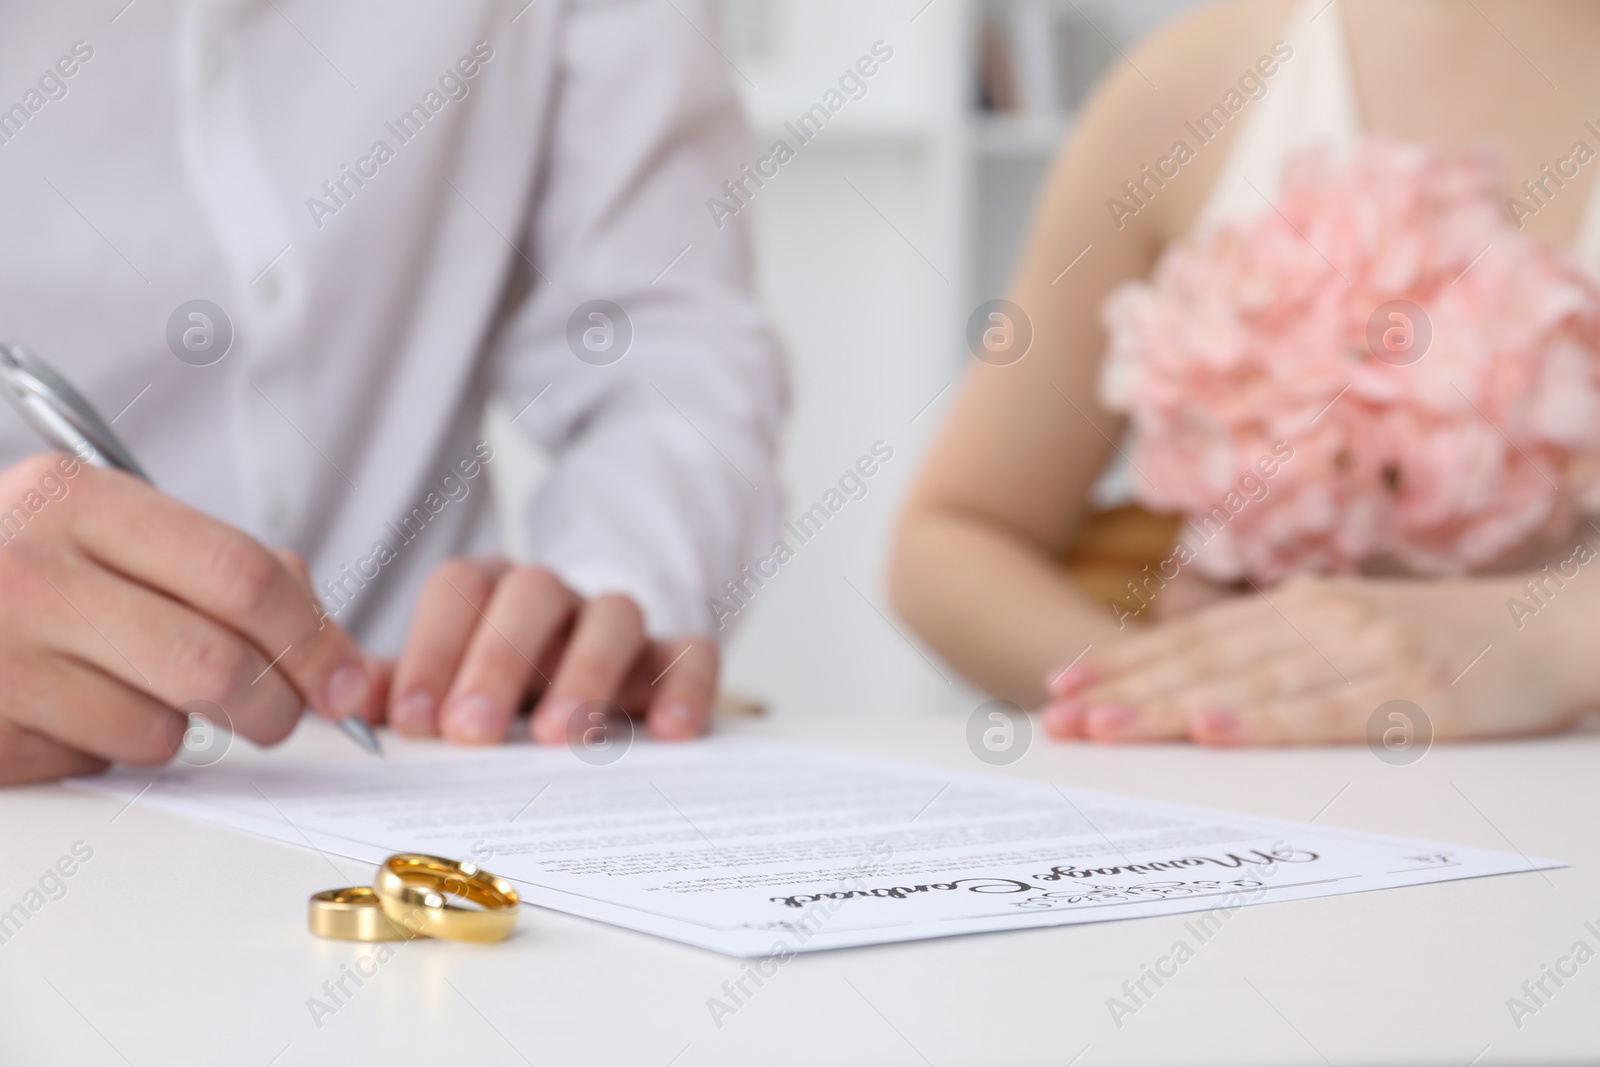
[491,0,787,637]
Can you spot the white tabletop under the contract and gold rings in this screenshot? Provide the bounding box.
[0,717,1600,1067]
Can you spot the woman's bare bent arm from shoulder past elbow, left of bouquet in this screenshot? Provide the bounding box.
[890,0,1288,705]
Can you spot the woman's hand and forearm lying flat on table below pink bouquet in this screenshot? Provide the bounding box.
[1043,573,1600,744]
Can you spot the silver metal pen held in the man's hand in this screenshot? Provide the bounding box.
[0,341,382,755]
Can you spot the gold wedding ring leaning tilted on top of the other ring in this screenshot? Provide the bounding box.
[373,853,520,942]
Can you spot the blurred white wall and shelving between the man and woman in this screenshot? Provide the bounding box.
[491,0,1195,715]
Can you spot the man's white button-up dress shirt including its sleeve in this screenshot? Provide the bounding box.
[0,0,786,653]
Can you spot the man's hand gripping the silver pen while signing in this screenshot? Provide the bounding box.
[0,453,381,782]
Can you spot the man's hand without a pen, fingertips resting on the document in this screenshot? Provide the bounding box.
[387,560,717,744]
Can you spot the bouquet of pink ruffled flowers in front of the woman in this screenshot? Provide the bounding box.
[1101,139,1600,582]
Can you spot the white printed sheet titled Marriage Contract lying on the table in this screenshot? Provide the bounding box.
[75,739,1562,957]
